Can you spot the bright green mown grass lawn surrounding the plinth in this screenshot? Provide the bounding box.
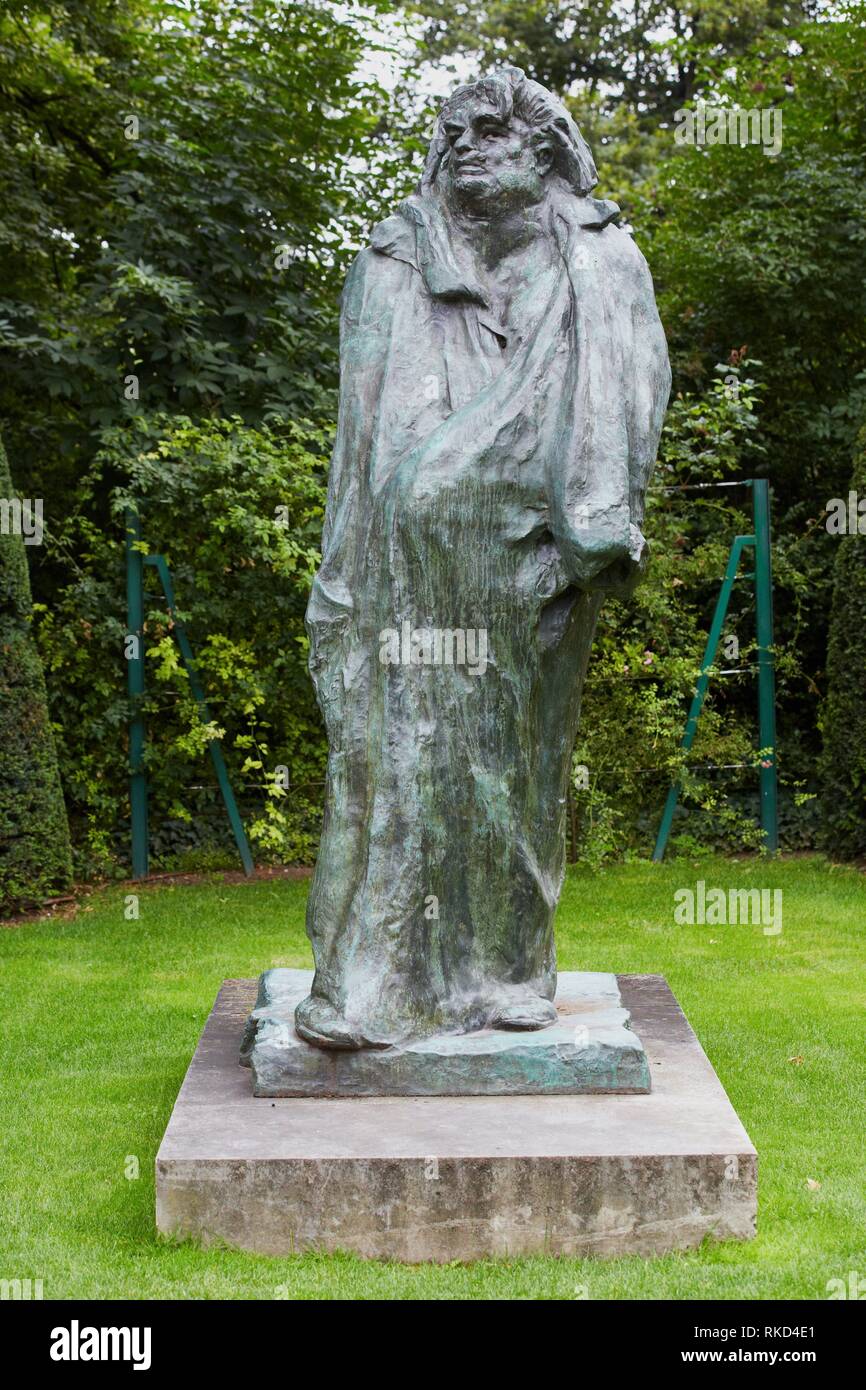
[0,859,866,1298]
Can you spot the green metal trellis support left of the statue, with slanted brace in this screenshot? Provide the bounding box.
[126,509,253,878]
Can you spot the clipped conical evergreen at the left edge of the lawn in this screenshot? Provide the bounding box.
[0,430,72,912]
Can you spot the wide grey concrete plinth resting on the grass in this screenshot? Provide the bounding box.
[157,976,756,1261]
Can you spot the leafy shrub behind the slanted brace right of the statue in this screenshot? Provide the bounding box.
[570,361,798,863]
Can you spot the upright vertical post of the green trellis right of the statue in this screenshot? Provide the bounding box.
[752,478,778,853]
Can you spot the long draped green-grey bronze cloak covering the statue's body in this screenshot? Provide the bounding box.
[297,178,670,1043]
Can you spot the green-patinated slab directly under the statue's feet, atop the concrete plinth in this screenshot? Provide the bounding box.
[240,969,651,1097]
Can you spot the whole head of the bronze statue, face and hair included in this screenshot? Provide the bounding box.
[421,67,598,215]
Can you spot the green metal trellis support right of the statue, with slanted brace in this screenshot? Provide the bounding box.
[652,478,778,862]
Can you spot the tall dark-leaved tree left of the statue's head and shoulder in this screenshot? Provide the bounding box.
[0,0,397,500]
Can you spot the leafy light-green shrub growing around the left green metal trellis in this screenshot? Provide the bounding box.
[39,414,329,874]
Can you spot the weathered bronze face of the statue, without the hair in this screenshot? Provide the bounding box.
[443,97,550,215]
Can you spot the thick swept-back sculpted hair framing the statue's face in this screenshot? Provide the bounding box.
[420,67,598,197]
